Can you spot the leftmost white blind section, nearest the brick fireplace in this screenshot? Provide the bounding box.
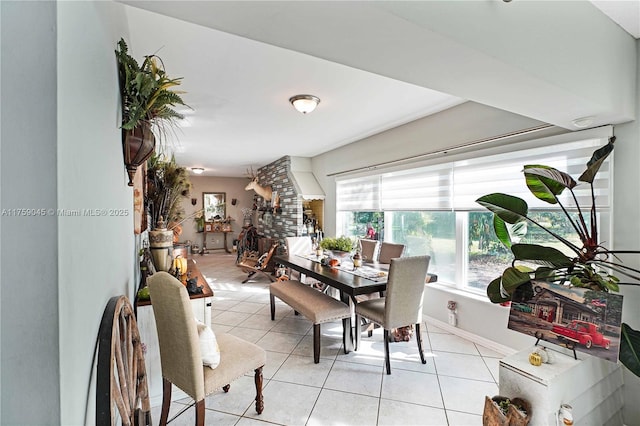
[336,175,380,211]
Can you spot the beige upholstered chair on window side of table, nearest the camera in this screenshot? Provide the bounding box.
[355,256,431,374]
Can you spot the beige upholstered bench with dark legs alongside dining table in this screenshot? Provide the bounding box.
[269,280,351,364]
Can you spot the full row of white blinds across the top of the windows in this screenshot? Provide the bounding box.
[336,136,611,211]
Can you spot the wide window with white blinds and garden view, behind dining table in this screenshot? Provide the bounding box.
[336,131,611,292]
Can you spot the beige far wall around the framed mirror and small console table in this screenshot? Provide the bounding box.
[180,175,256,248]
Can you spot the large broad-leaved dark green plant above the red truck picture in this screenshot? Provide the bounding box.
[476,137,640,377]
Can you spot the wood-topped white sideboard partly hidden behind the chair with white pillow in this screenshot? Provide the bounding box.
[136,259,213,407]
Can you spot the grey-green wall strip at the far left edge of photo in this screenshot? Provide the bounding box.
[0,1,60,424]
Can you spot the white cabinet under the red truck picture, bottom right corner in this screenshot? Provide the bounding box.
[499,347,623,426]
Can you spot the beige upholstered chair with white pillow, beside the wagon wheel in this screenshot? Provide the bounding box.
[148,272,266,425]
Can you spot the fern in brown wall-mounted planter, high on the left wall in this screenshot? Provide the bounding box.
[115,39,187,186]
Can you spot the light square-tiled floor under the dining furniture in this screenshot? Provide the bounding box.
[152,252,502,426]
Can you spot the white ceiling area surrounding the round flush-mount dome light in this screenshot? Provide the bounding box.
[124,1,640,176]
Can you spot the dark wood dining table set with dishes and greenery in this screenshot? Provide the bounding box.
[273,254,437,353]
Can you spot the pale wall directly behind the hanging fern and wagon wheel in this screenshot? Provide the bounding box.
[57,2,136,425]
